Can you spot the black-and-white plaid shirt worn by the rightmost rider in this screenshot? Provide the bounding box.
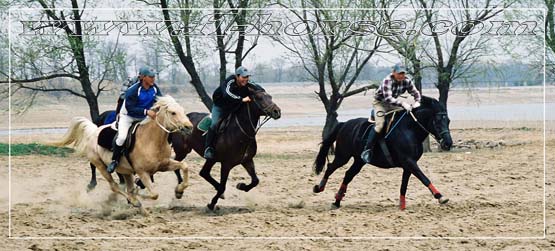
[374,75,420,106]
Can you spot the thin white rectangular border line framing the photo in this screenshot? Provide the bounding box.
[8,7,547,240]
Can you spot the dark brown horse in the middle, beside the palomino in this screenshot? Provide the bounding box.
[172,87,281,210]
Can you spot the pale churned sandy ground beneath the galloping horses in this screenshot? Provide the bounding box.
[0,86,555,250]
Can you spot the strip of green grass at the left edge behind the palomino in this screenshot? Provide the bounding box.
[0,143,73,157]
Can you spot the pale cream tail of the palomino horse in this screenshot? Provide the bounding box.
[50,117,98,154]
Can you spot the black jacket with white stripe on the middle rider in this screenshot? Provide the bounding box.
[212,75,250,111]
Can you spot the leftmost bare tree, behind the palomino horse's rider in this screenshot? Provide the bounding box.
[0,0,122,120]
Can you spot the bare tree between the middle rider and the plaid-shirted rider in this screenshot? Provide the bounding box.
[273,0,382,137]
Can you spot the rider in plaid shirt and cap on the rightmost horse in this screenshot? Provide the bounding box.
[360,64,420,163]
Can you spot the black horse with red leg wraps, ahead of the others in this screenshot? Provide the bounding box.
[313,97,453,210]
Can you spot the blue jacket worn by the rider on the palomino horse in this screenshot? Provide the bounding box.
[125,82,162,118]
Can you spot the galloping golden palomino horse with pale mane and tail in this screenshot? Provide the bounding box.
[54,96,192,210]
